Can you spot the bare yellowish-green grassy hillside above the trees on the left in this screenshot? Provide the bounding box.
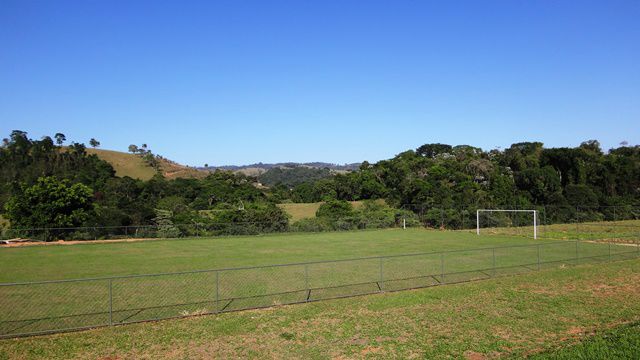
[87,148,208,180]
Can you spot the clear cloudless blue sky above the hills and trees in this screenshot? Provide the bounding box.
[0,0,640,165]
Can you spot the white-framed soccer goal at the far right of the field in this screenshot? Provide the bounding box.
[476,209,538,239]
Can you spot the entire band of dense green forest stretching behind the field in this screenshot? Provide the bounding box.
[0,131,640,236]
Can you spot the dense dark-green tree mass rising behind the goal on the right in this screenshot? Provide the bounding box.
[274,140,640,225]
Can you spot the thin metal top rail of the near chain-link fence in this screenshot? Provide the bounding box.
[0,240,579,287]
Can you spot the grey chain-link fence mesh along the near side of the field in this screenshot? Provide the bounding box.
[0,241,640,338]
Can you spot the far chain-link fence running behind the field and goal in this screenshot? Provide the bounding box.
[0,204,640,241]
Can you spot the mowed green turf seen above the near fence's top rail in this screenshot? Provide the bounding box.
[0,229,540,282]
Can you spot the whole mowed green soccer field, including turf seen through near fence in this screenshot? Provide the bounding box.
[0,229,638,336]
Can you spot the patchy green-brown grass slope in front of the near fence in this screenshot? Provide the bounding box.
[0,260,640,359]
